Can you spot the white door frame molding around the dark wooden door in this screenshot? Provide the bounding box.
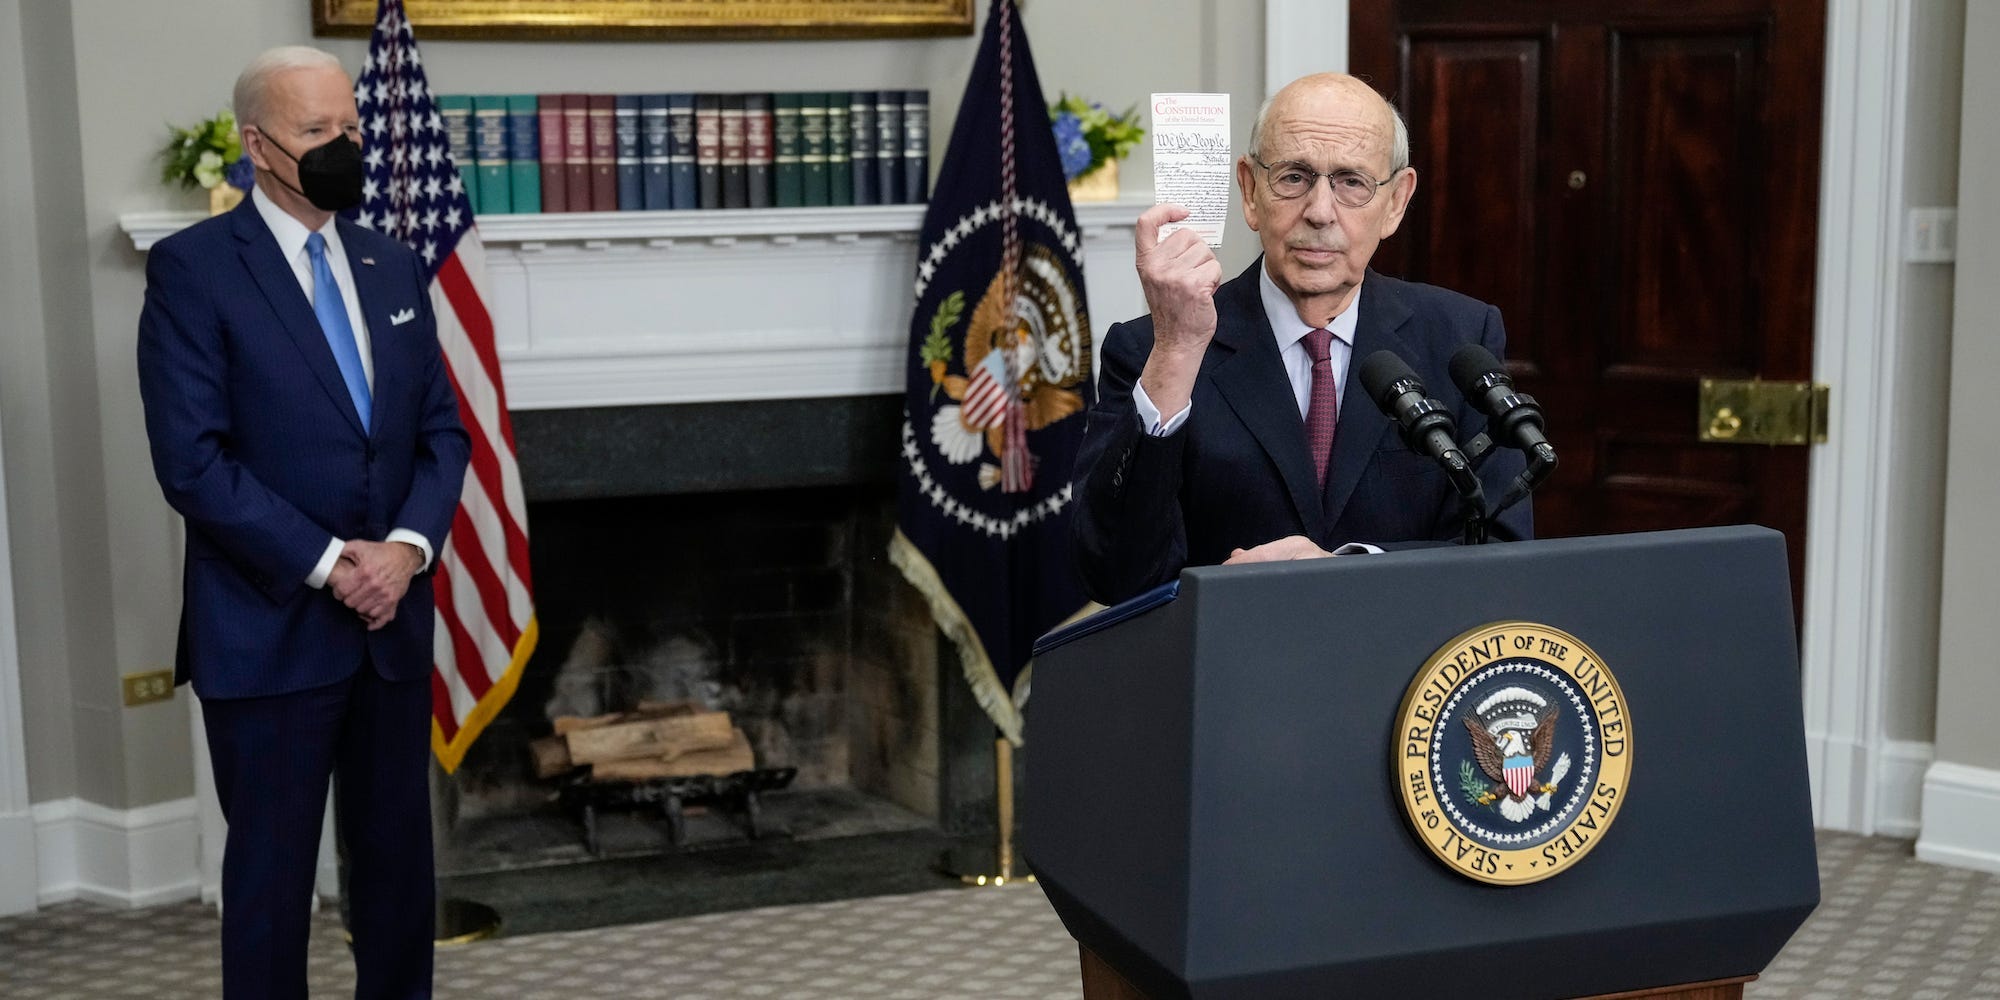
[1288,0,1920,836]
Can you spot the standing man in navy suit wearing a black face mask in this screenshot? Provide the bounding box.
[138,48,470,1000]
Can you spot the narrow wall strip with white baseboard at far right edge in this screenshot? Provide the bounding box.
[1916,2,2000,872]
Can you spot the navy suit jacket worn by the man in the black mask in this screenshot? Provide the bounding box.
[138,198,470,698]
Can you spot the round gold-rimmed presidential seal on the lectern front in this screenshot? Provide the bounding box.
[1394,622,1632,886]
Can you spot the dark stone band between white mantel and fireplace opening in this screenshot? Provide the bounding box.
[514,396,902,500]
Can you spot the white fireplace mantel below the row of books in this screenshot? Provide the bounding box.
[118,198,1152,410]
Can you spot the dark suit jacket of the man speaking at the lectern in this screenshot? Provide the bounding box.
[1074,258,1532,604]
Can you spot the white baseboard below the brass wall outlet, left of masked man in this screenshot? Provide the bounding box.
[34,798,202,908]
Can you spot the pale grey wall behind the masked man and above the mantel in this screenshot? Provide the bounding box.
[0,0,1264,810]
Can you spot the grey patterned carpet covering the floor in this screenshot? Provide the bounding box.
[0,834,2000,1000]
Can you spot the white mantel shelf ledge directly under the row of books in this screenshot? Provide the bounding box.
[118,196,1152,252]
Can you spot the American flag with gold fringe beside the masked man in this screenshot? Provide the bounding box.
[354,0,536,772]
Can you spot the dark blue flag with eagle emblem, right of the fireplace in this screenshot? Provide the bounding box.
[890,0,1096,744]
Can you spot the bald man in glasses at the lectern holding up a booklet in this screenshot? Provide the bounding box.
[1074,74,1532,604]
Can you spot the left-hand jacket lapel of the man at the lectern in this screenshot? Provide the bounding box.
[1208,258,1338,538]
